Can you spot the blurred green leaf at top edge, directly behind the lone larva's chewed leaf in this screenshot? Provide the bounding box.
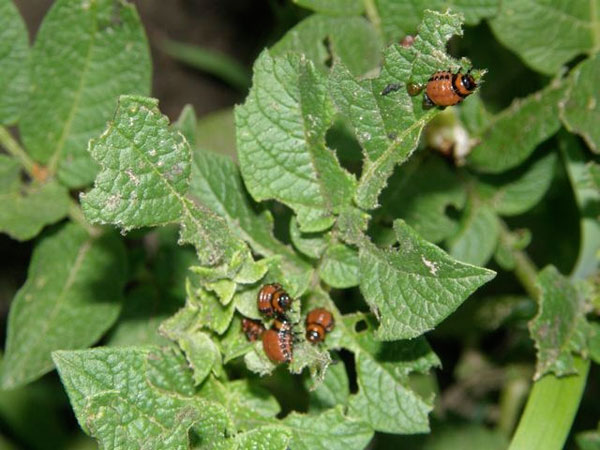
[375,0,499,42]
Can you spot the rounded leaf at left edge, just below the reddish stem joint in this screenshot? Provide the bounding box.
[0,154,69,241]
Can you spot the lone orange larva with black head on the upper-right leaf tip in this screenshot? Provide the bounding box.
[425,70,477,107]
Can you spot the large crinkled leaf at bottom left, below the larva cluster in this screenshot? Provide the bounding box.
[52,347,231,450]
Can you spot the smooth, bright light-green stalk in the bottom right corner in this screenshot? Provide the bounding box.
[509,356,590,450]
